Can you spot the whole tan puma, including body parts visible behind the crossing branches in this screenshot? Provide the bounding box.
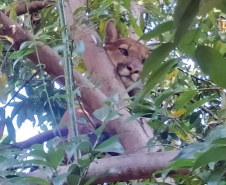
[61,20,149,134]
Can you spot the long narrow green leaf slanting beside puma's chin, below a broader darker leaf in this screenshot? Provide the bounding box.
[132,59,177,109]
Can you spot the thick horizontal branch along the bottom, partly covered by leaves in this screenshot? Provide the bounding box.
[29,151,185,184]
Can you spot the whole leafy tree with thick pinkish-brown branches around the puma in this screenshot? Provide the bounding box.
[0,0,226,184]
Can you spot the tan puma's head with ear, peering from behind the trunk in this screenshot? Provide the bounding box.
[105,20,149,92]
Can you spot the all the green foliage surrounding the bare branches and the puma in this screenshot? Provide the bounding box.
[0,0,226,184]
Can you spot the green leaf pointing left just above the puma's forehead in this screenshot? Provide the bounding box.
[139,21,174,40]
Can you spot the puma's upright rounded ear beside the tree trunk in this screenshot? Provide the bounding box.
[105,20,120,44]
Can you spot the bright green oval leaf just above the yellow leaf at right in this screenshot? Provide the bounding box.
[175,90,198,110]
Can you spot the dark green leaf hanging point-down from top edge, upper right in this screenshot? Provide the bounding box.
[174,0,201,45]
